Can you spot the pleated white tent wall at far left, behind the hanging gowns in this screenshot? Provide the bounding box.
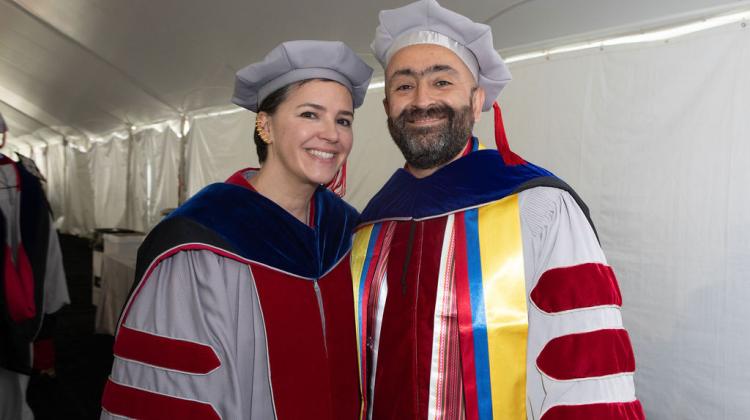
[12,122,182,236]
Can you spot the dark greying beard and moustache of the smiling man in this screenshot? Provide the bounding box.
[388,104,474,169]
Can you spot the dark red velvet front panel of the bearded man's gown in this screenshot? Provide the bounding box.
[373,217,446,420]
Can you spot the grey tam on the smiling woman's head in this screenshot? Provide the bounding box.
[232,40,372,112]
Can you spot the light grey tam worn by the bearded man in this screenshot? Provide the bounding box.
[371,0,511,111]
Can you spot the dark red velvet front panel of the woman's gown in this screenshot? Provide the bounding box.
[251,260,360,420]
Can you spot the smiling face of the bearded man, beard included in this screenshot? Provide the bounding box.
[383,44,484,169]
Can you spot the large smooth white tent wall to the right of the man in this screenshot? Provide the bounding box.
[502,25,750,420]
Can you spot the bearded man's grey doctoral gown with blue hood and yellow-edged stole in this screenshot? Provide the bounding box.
[351,138,643,420]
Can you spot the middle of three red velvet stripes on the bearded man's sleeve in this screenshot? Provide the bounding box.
[537,329,635,381]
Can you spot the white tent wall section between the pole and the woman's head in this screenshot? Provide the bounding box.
[186,111,258,196]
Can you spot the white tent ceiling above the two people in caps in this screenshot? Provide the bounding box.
[0,0,750,136]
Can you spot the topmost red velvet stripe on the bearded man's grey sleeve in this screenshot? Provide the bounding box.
[531,263,622,313]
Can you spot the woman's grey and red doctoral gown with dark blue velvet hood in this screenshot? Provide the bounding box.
[102,170,360,420]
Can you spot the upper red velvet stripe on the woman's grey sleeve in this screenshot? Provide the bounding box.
[114,325,221,374]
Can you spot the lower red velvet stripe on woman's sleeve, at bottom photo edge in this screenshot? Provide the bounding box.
[102,379,221,420]
